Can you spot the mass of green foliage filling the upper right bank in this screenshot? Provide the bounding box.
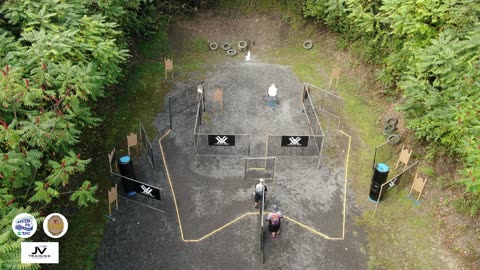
[304,0,480,196]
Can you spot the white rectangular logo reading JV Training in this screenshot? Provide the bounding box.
[21,242,59,263]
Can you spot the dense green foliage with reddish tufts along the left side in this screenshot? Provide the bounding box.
[0,0,135,269]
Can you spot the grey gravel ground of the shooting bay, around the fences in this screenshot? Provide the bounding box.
[96,62,367,269]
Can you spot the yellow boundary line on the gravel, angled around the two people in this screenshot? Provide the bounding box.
[158,129,352,243]
